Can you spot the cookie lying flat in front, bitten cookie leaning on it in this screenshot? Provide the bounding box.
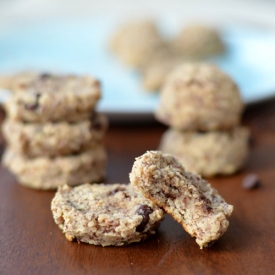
[51,184,164,246]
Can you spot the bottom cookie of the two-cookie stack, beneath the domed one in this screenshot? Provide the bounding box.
[159,127,249,177]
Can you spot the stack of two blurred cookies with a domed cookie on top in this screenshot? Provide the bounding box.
[155,63,249,176]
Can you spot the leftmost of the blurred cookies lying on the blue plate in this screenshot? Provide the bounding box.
[110,20,165,68]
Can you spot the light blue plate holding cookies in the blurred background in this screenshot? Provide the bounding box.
[0,17,275,118]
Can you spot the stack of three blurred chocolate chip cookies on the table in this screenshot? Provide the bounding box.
[2,74,108,189]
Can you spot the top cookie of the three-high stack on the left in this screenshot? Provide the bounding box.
[5,74,101,122]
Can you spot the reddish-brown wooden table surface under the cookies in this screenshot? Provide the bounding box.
[0,100,275,275]
